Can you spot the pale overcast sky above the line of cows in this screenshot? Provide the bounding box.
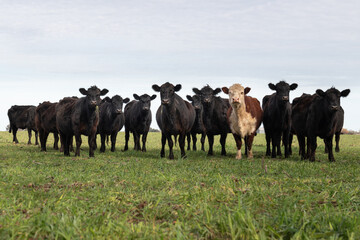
[0,0,360,130]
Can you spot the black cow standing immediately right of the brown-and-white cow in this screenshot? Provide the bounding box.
[262,81,298,158]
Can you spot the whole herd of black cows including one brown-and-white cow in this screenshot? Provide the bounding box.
[8,81,350,161]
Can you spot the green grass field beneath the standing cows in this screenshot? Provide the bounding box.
[0,132,360,239]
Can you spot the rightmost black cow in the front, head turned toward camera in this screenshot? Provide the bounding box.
[292,88,350,162]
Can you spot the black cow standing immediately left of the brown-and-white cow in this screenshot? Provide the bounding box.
[193,85,230,155]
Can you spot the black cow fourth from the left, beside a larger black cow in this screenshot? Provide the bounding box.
[97,95,130,152]
